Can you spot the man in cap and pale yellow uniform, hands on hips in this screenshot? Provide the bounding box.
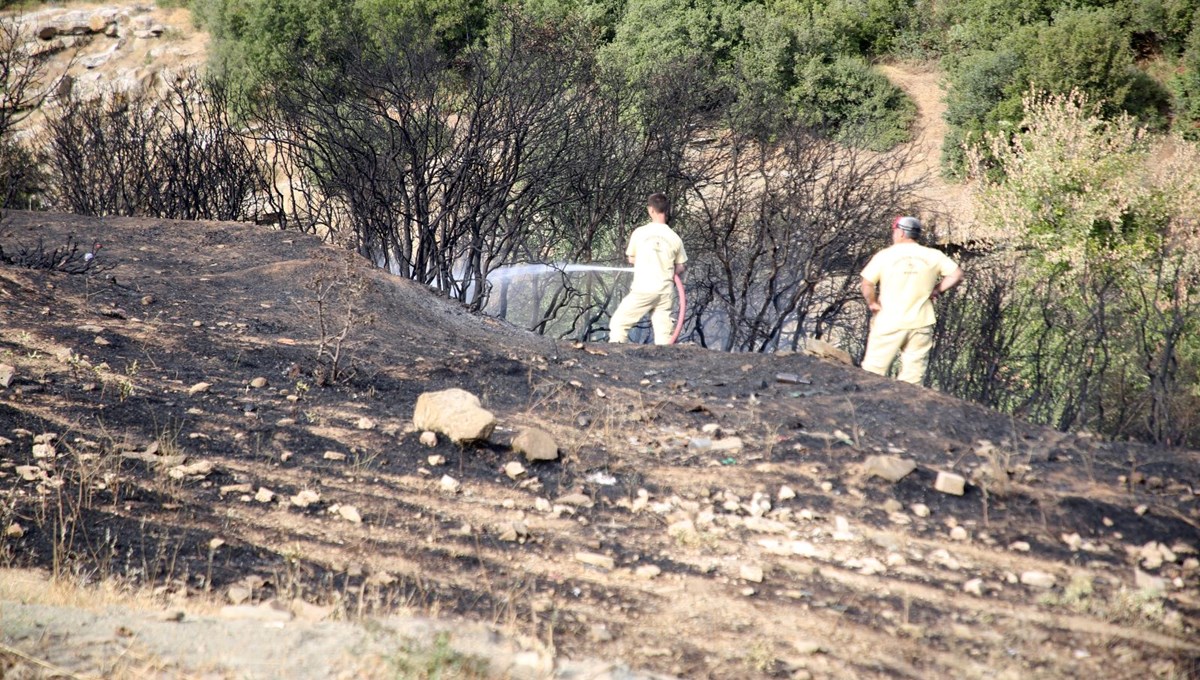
[862,217,962,385]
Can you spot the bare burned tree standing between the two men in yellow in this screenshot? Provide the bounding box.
[685,125,914,351]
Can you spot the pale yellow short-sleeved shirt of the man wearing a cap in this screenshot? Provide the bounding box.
[863,243,959,332]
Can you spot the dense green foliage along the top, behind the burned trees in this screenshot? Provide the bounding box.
[191,0,1200,157]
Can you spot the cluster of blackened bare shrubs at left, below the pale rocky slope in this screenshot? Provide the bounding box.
[47,78,271,219]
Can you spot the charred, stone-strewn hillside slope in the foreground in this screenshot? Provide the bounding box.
[0,212,1200,679]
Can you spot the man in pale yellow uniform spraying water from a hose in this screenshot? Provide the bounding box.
[608,193,688,344]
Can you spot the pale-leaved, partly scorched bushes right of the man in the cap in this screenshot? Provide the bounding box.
[932,95,1200,446]
